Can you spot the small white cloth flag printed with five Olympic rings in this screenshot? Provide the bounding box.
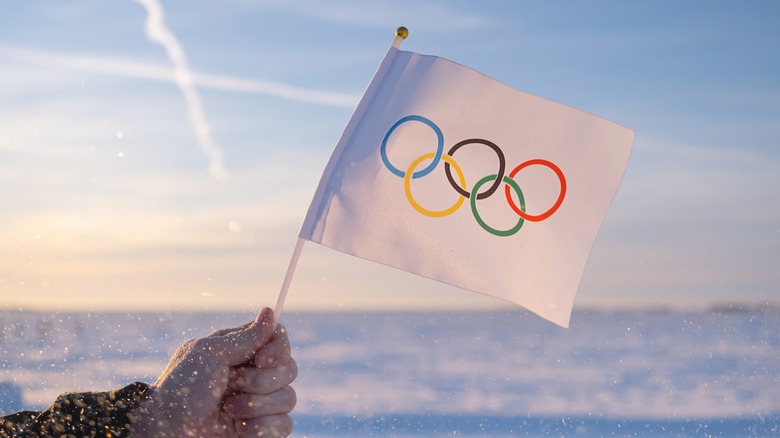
[299,42,634,327]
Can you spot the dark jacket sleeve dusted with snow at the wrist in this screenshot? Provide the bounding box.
[0,382,149,438]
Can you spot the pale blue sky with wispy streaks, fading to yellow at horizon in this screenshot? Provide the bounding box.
[0,0,780,310]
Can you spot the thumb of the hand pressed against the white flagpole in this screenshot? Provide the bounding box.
[204,308,274,366]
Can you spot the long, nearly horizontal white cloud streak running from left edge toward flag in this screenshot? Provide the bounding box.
[0,44,360,109]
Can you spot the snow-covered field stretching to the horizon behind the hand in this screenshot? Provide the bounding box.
[0,309,780,437]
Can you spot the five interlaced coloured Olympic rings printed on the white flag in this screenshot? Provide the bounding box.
[380,115,566,237]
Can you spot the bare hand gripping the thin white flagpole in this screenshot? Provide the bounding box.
[133,308,298,438]
